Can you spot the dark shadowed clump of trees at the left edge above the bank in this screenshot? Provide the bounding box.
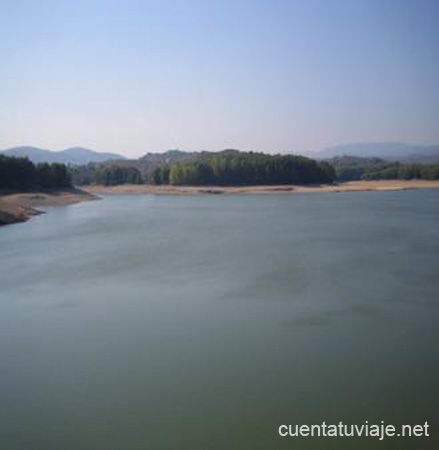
[0,155,71,190]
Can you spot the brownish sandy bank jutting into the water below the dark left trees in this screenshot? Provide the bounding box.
[0,188,98,225]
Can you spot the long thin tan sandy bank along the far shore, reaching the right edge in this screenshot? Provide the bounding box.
[85,180,439,195]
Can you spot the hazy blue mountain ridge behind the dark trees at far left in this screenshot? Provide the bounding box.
[0,146,126,165]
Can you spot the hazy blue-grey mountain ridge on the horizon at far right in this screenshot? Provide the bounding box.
[308,142,439,163]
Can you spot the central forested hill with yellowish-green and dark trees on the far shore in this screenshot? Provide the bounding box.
[72,150,335,186]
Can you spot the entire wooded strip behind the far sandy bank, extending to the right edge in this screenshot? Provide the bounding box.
[51,150,439,186]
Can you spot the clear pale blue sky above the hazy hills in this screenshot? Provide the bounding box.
[0,0,439,157]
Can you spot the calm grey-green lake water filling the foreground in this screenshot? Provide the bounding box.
[0,190,439,450]
